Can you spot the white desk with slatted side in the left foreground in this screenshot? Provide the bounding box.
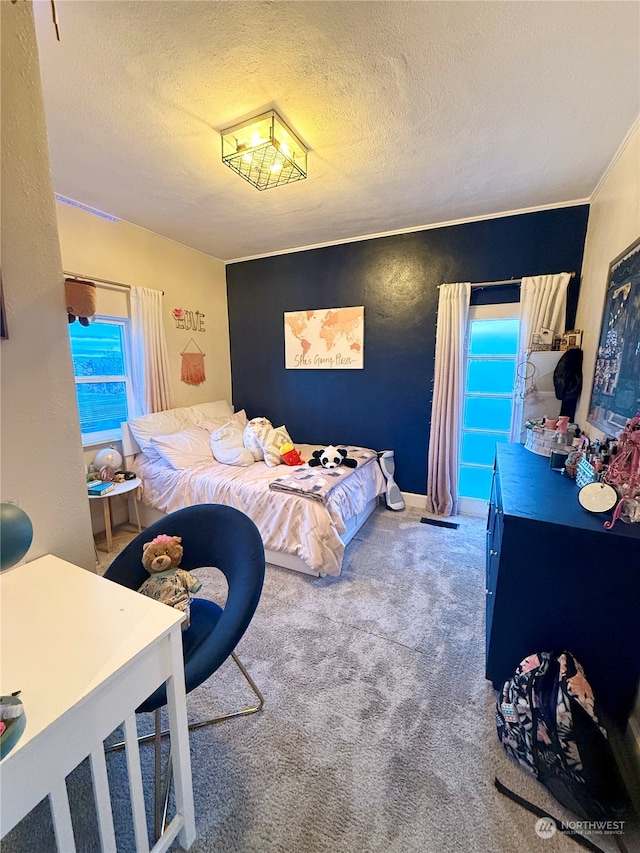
[0,555,195,853]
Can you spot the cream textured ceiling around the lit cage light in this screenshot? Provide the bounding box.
[34,0,640,260]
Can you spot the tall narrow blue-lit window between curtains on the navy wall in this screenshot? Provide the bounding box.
[458,305,520,501]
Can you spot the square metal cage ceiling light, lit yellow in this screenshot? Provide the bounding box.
[222,110,307,190]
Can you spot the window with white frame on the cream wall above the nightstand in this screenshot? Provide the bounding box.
[69,317,131,444]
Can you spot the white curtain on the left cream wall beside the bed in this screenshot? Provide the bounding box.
[131,287,171,417]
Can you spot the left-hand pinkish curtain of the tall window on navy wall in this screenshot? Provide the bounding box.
[426,282,471,515]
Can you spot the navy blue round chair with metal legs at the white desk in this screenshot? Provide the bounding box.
[104,504,265,836]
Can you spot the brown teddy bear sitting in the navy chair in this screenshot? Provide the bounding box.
[138,533,202,631]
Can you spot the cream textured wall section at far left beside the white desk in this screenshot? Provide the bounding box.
[0,2,95,570]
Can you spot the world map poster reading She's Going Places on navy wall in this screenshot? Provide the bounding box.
[284,305,364,370]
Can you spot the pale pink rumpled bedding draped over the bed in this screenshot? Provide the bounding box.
[133,445,385,575]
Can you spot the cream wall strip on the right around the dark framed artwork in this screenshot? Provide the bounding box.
[576,119,640,438]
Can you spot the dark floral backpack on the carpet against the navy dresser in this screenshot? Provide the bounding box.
[496,652,628,849]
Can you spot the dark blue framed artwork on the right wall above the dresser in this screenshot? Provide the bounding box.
[587,238,640,438]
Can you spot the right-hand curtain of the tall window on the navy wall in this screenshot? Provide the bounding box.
[510,272,571,441]
